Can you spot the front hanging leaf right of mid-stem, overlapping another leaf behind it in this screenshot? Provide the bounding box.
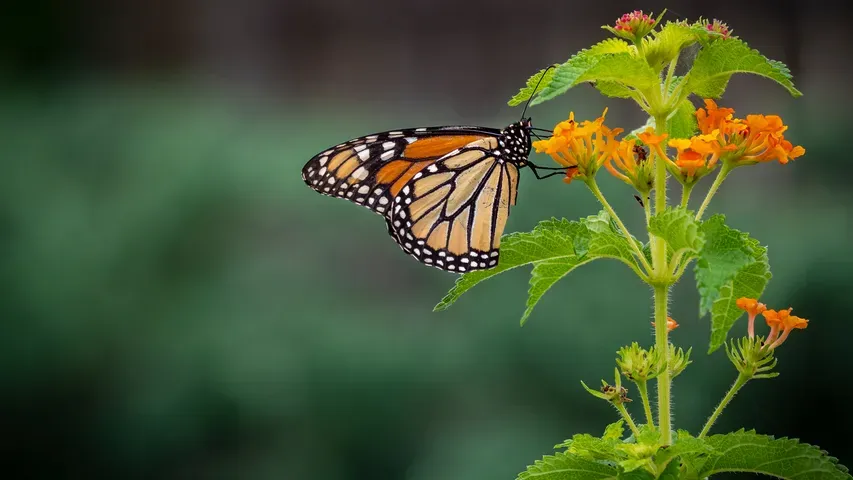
[694,214,763,317]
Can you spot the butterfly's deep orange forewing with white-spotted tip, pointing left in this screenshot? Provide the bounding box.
[302,126,500,217]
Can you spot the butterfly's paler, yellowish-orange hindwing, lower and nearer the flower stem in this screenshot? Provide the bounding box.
[387,137,518,273]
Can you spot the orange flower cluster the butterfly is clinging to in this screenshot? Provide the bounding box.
[533,108,622,183]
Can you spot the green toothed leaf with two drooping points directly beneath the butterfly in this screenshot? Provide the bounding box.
[435,212,638,324]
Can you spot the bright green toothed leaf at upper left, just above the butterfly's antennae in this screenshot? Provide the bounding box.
[530,52,660,105]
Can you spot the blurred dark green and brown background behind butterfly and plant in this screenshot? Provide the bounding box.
[0,0,853,480]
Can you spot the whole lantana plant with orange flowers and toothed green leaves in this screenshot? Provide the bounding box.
[436,11,853,480]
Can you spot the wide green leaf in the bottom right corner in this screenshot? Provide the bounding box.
[699,430,853,480]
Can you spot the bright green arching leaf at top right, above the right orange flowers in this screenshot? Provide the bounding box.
[685,38,802,98]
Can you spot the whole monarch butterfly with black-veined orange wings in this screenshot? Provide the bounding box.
[302,119,531,273]
